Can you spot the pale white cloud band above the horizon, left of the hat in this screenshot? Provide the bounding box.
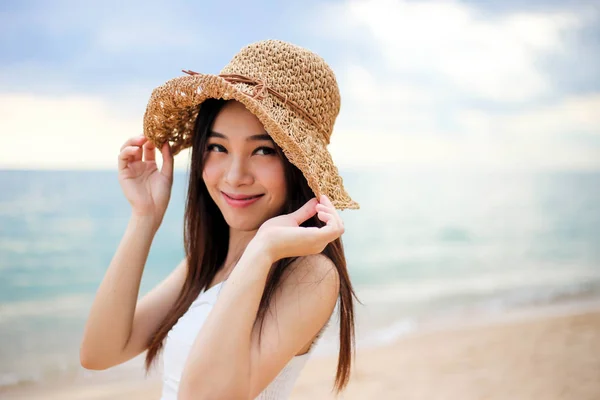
[0,94,188,171]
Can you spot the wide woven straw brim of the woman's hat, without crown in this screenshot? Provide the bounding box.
[144,74,360,210]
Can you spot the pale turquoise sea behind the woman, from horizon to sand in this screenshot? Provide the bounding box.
[0,169,600,392]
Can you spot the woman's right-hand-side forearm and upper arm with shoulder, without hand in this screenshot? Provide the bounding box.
[178,247,339,400]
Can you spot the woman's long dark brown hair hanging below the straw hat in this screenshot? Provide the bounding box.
[146,99,358,394]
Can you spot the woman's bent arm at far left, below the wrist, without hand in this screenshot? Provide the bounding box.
[80,216,187,369]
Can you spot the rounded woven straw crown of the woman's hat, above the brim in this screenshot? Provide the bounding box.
[221,40,340,142]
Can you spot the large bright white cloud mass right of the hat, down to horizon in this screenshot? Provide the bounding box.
[319,0,600,169]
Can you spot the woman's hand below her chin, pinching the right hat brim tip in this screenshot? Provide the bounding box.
[252,195,344,262]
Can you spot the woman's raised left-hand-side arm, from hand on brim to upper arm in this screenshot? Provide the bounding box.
[80,136,178,369]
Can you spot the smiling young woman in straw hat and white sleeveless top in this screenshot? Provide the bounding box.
[80,40,358,400]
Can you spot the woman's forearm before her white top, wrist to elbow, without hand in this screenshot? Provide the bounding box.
[178,245,271,400]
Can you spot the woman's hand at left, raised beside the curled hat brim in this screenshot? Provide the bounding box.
[119,136,173,229]
